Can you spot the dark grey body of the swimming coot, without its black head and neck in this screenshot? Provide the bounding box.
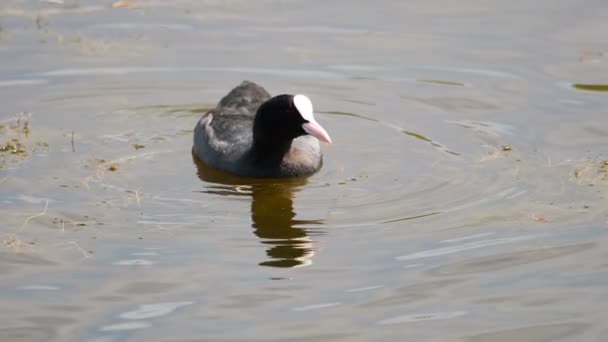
[193,81,322,177]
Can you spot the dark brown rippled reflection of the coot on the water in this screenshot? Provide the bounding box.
[192,155,324,267]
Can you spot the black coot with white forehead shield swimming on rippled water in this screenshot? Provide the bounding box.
[193,81,331,177]
